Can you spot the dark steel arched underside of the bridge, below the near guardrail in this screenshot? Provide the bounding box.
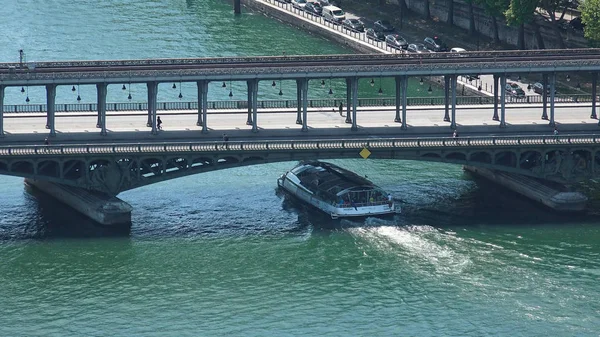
[0,143,600,196]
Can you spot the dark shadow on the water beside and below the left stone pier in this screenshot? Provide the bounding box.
[10,184,131,239]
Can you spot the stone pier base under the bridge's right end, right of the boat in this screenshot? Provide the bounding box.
[464,166,588,212]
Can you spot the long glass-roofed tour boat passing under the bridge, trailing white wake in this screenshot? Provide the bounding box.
[277,161,400,219]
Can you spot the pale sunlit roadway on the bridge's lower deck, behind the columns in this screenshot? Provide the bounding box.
[0,104,600,145]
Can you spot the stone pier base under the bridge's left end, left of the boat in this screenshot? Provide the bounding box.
[25,178,133,226]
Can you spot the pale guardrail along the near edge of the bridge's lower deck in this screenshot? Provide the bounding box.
[0,134,600,157]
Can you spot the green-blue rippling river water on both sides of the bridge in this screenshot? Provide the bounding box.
[0,0,600,336]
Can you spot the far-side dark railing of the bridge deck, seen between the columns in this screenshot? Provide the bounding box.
[4,94,592,113]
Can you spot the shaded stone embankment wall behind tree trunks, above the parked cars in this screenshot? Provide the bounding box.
[392,0,588,49]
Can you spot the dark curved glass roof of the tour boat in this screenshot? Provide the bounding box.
[291,161,379,195]
